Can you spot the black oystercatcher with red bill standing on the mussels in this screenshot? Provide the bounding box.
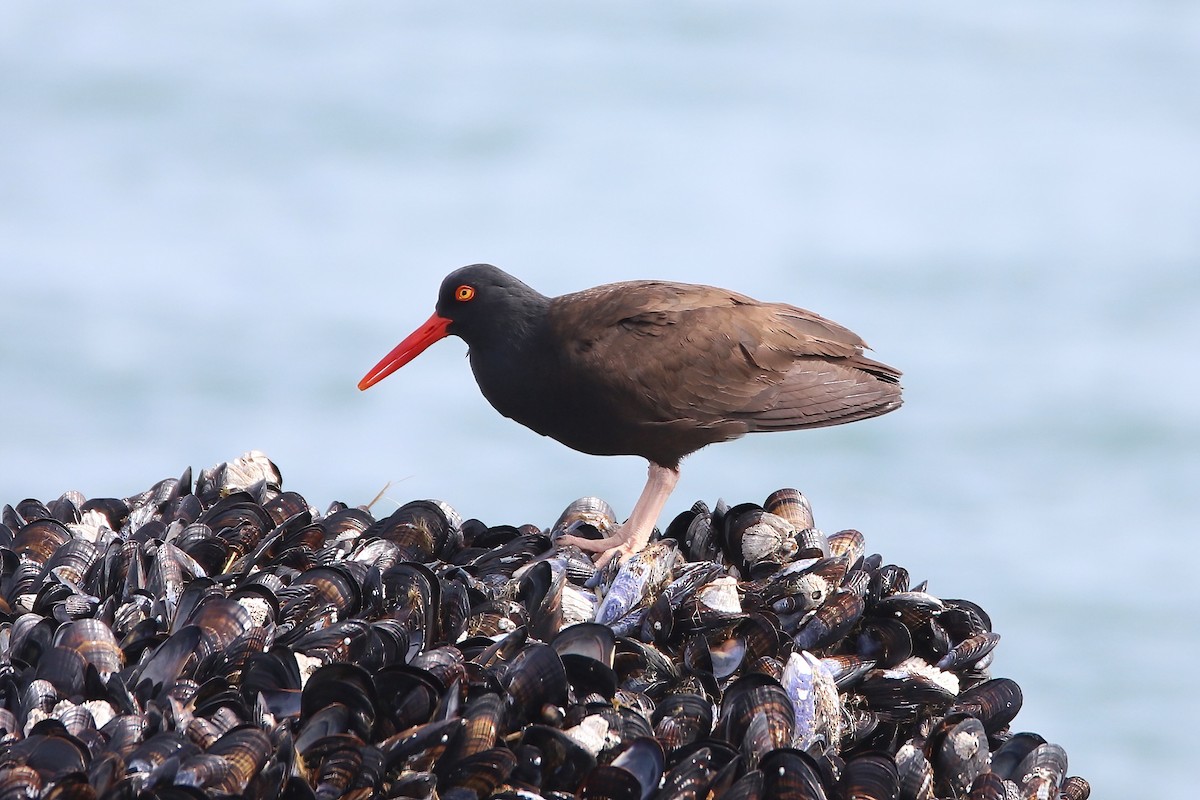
[359,264,900,561]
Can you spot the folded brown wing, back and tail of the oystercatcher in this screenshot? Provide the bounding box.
[548,281,900,441]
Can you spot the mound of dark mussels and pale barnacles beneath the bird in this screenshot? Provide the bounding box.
[0,452,1090,800]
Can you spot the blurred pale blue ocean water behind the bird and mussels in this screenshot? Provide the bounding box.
[0,0,1200,796]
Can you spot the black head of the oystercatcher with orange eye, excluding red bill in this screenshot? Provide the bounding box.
[437,264,547,344]
